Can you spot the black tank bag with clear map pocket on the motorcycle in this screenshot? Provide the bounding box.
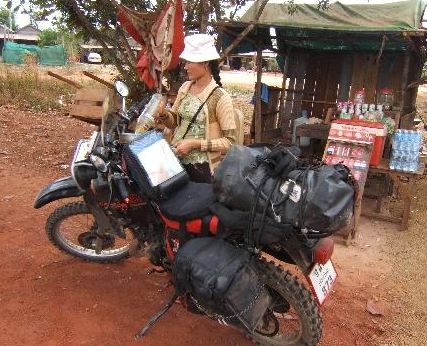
[123,130,189,200]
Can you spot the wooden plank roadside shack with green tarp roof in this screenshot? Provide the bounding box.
[220,0,427,143]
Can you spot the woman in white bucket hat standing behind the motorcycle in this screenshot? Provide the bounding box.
[159,34,237,183]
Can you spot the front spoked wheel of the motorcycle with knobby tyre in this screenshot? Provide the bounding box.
[46,202,138,263]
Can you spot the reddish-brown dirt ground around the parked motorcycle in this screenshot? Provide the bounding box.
[0,107,427,346]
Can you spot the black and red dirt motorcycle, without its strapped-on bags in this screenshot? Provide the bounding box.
[34,81,337,345]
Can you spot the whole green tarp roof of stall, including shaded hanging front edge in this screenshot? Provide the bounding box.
[222,0,426,53]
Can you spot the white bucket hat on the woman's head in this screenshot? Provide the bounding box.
[179,34,220,62]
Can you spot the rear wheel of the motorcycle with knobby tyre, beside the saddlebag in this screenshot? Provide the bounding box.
[249,262,322,346]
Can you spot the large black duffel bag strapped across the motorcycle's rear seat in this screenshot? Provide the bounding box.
[214,145,354,235]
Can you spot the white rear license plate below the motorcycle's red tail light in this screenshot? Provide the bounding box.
[308,260,337,305]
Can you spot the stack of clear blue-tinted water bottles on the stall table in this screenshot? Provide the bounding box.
[390,129,422,173]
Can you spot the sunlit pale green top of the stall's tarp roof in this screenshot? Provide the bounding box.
[241,0,426,32]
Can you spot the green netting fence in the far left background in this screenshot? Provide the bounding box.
[3,42,67,66]
